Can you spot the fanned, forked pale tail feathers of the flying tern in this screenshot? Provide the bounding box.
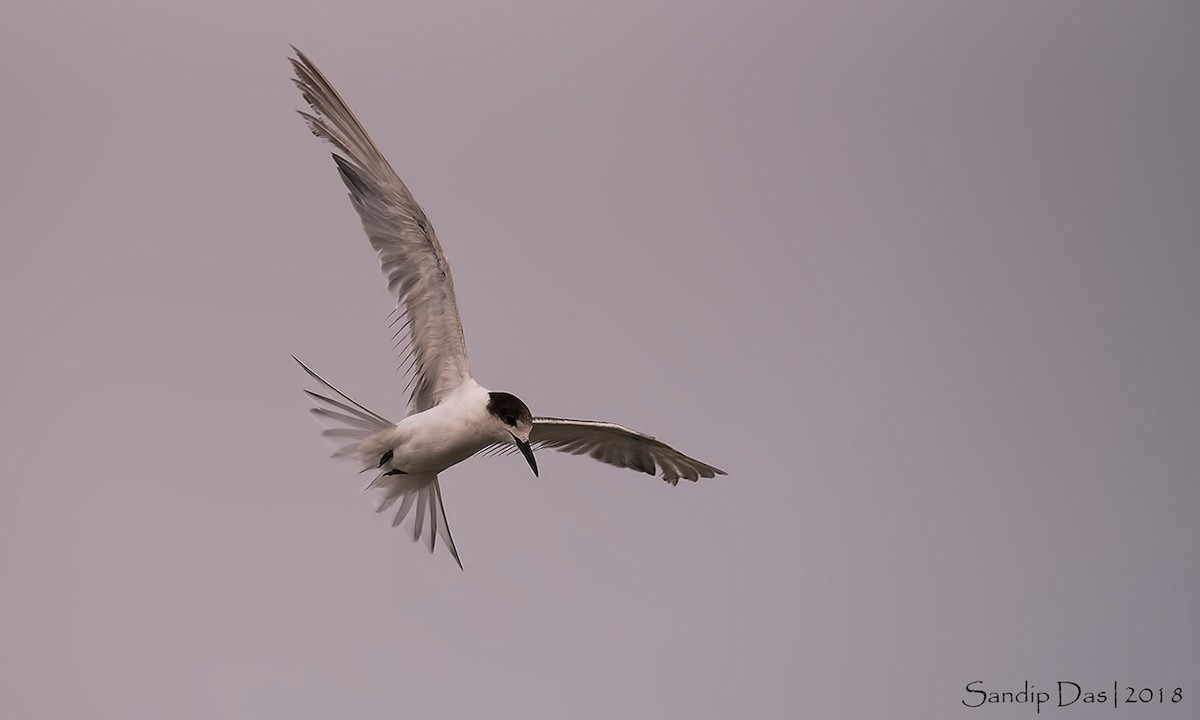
[292,355,462,569]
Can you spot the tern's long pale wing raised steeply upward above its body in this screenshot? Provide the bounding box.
[292,47,470,413]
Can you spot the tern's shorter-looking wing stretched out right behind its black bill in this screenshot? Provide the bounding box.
[529,418,725,485]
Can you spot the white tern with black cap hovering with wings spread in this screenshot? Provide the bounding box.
[289,47,725,568]
